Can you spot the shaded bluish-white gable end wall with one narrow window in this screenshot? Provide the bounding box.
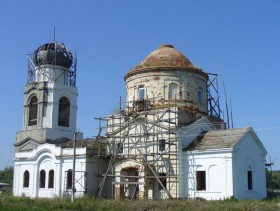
[233,133,266,199]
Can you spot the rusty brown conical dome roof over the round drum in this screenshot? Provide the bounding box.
[125,44,208,78]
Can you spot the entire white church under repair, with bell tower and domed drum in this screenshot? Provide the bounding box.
[13,42,267,200]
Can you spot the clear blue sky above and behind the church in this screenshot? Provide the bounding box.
[0,0,280,170]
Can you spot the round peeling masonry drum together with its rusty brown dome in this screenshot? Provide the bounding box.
[124,44,208,118]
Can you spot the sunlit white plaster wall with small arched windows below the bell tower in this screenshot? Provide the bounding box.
[13,144,87,198]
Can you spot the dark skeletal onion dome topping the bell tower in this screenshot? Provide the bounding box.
[33,42,73,69]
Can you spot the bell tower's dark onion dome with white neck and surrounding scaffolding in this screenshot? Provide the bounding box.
[27,42,77,86]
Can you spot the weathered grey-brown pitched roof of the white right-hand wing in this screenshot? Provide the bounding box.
[184,127,252,151]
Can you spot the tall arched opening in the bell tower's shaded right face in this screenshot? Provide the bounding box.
[58,97,70,127]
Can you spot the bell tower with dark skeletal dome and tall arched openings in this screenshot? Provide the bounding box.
[15,42,78,151]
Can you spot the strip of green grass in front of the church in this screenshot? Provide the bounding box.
[0,196,280,211]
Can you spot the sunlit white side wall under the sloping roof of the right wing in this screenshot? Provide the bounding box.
[184,149,233,200]
